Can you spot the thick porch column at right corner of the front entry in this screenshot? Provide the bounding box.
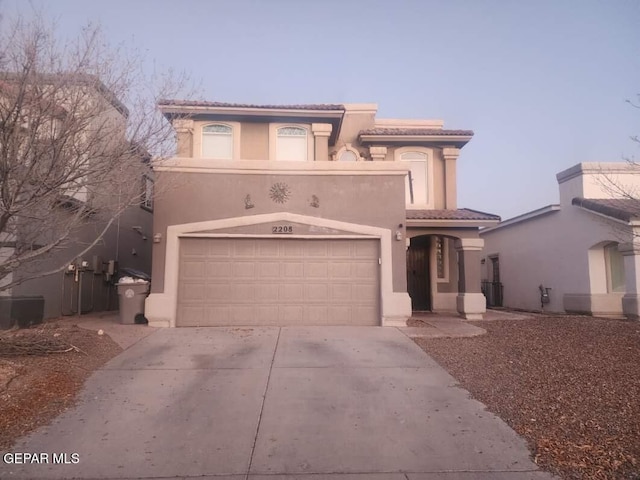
[455,238,487,320]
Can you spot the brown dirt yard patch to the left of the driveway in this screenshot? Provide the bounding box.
[0,322,122,450]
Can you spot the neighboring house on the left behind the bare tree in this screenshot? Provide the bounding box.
[0,74,153,328]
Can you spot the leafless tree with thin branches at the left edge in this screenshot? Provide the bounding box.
[0,14,185,291]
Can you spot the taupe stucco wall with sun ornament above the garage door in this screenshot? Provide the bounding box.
[152,172,406,292]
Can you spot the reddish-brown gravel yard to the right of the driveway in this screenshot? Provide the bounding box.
[413,315,640,480]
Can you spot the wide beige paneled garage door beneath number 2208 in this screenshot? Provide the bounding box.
[176,238,380,326]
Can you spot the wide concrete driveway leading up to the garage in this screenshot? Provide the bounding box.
[0,327,552,480]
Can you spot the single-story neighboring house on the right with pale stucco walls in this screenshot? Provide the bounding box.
[480,163,640,318]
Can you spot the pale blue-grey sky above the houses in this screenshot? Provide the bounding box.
[5,0,640,219]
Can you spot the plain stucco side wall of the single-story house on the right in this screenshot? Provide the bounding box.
[480,206,620,312]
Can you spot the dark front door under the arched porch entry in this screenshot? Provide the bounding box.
[407,237,431,310]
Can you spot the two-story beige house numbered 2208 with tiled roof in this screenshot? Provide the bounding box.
[145,100,499,327]
